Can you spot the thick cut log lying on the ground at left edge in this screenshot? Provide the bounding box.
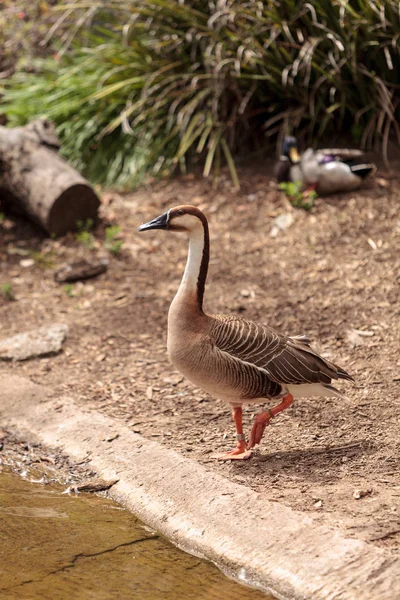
[0,119,100,235]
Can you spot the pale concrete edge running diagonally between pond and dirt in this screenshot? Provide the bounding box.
[0,375,400,600]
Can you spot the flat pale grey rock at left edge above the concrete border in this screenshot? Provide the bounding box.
[0,323,68,360]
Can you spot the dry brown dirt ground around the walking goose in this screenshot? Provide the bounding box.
[0,163,400,550]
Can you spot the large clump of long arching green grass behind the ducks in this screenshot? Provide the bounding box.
[2,0,400,186]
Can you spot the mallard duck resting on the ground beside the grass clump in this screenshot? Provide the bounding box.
[275,136,376,195]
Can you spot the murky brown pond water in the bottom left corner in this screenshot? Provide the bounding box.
[0,472,273,600]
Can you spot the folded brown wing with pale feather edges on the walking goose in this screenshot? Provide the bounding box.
[211,315,352,385]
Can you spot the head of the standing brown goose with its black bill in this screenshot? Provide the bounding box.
[138,205,207,235]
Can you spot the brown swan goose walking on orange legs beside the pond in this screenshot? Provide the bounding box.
[139,205,354,460]
